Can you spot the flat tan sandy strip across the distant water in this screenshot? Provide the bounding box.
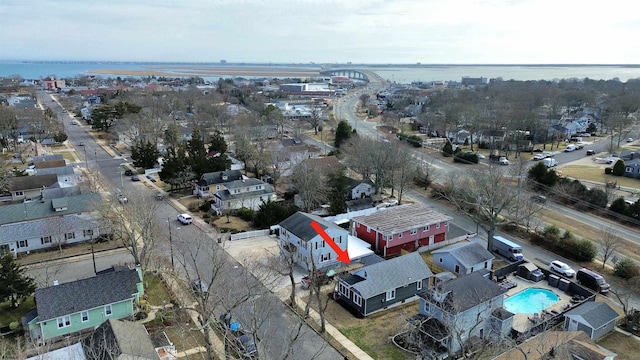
[88,65,320,77]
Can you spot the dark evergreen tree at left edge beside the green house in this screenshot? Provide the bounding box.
[0,252,36,308]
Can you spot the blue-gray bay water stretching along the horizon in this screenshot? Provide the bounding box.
[0,61,640,83]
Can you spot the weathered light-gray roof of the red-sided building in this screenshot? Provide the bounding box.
[353,204,453,235]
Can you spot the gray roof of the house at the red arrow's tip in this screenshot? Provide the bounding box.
[351,252,433,299]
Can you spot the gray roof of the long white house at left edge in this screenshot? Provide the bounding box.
[0,215,97,244]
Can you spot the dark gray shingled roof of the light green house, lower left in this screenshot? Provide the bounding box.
[35,269,140,322]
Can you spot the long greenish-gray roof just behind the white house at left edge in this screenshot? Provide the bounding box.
[0,191,102,225]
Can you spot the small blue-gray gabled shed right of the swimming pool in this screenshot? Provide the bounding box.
[564,301,618,341]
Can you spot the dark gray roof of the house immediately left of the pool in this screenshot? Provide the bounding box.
[418,272,505,313]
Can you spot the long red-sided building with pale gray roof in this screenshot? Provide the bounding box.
[351,204,452,257]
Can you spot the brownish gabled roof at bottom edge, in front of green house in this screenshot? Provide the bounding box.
[83,319,160,360]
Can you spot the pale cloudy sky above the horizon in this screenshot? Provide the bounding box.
[0,0,640,64]
